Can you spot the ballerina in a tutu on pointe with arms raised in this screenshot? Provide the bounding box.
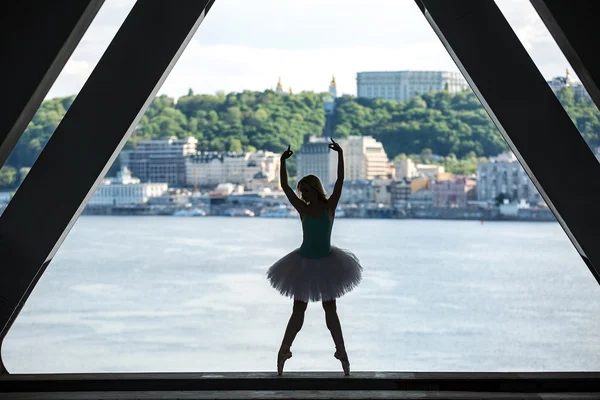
[267,139,362,375]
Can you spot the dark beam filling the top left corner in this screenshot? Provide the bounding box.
[0,0,104,167]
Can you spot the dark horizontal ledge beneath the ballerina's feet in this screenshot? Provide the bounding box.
[0,371,600,399]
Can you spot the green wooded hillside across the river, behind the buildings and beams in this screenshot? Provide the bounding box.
[7,88,600,171]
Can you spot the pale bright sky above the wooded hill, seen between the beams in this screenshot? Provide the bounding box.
[47,0,576,98]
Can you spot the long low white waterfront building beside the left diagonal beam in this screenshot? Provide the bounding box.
[88,168,169,206]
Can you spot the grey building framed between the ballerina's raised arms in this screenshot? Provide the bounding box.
[296,136,338,189]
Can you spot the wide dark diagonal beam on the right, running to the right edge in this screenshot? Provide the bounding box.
[416,0,600,283]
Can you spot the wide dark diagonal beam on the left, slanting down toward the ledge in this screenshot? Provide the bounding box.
[0,0,214,368]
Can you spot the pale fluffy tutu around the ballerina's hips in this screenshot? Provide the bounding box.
[267,246,362,303]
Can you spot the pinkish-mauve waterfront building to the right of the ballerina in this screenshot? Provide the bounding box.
[431,177,477,208]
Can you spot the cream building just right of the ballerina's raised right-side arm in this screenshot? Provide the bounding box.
[338,136,390,180]
